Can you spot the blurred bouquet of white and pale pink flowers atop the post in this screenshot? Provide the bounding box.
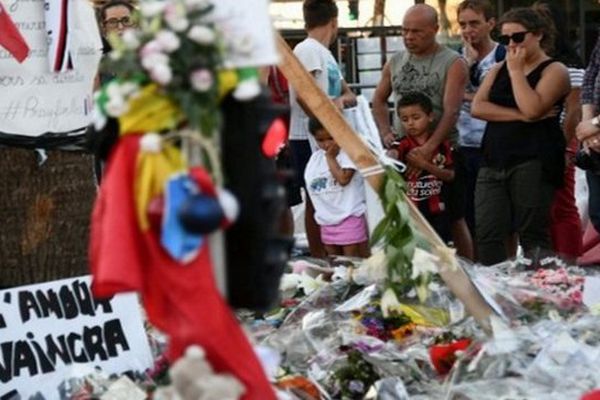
[96,0,260,136]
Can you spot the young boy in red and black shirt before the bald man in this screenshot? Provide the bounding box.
[389,92,454,242]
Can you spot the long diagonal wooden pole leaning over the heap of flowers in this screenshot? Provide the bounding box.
[277,34,493,328]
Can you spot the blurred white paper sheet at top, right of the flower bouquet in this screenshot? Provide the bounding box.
[213,0,279,67]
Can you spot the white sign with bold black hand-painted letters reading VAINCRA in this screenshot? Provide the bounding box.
[0,276,152,400]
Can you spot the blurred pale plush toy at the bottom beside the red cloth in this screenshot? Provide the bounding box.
[154,345,245,400]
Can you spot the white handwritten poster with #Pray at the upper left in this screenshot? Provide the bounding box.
[0,0,102,137]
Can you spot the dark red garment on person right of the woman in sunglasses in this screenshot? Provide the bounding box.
[550,141,583,258]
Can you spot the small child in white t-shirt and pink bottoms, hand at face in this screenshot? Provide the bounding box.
[304,118,369,257]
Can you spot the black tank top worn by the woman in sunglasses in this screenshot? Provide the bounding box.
[482,59,566,184]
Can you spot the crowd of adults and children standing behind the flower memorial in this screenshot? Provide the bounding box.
[98,0,600,264]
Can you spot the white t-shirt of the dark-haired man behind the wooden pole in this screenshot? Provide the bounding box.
[289,37,343,140]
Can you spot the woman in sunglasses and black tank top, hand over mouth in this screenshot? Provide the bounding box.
[472,8,570,265]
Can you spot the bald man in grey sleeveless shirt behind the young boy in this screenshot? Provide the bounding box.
[373,4,473,259]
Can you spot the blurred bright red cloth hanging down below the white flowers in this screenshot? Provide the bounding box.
[90,135,275,400]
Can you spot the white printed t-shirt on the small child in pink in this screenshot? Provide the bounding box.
[304,149,367,225]
